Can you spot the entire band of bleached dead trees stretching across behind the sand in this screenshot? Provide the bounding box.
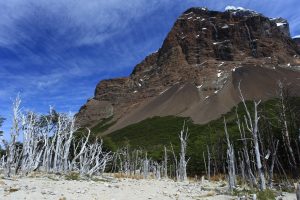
[0,83,300,194]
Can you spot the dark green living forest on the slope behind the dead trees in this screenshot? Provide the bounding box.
[94,98,300,175]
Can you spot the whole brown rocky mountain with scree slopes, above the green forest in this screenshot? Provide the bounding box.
[77,8,300,134]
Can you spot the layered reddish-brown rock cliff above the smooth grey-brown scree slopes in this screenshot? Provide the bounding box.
[77,8,300,129]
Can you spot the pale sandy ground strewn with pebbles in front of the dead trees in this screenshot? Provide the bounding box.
[0,176,296,200]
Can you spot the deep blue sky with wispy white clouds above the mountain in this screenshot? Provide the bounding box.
[0,0,300,136]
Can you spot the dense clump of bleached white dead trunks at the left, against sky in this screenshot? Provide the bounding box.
[1,96,111,176]
